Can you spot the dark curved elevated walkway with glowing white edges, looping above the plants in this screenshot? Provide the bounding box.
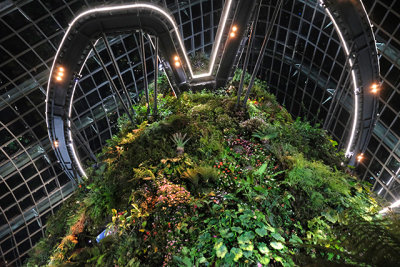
[46,0,379,180]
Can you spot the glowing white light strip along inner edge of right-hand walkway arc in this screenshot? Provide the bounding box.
[319,0,359,158]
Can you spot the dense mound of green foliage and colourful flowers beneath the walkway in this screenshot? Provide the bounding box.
[26,72,400,266]
